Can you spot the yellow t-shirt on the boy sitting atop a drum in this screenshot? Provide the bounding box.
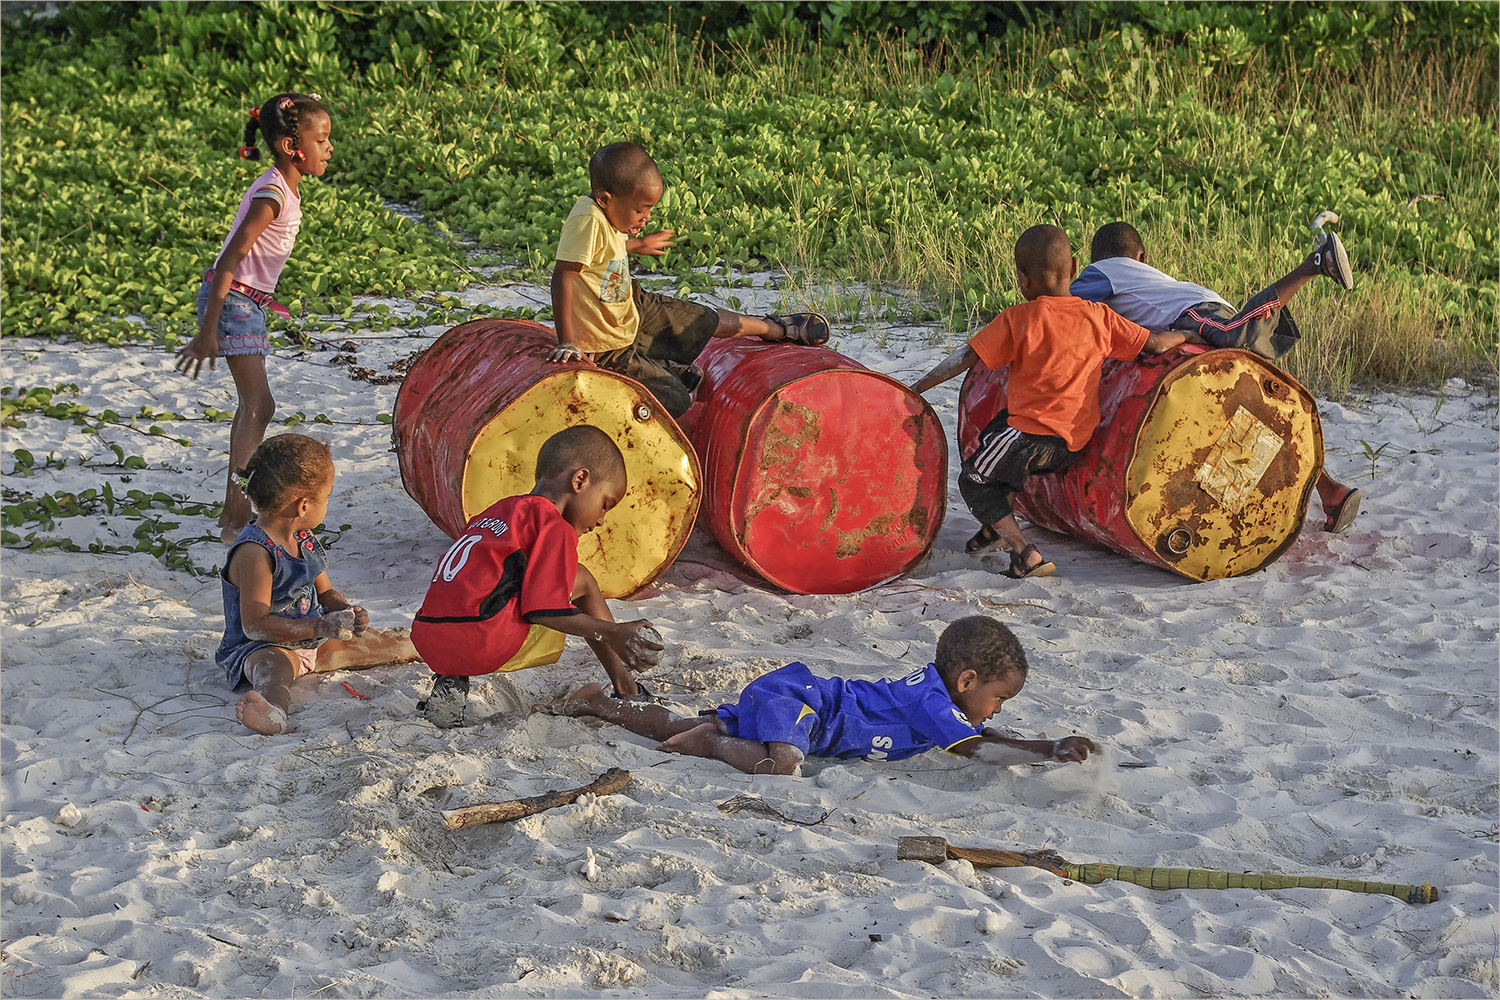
[557,198,641,354]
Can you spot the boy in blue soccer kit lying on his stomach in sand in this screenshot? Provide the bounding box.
[534,616,1098,774]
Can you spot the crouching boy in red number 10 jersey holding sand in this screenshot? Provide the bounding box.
[411,424,662,729]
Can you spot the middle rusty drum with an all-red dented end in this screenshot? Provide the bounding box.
[684,339,948,594]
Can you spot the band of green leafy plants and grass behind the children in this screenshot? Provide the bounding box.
[0,3,1500,394]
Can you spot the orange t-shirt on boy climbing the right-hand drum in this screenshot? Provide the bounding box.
[969,295,1151,451]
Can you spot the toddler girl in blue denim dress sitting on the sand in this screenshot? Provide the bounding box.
[215,433,417,736]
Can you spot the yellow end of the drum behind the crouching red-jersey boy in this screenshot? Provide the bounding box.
[464,369,702,597]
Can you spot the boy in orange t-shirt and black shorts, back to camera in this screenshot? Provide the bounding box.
[912,226,1190,580]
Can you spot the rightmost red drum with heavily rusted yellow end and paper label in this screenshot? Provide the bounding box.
[959,346,1323,580]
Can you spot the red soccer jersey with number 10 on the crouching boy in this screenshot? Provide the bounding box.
[411,496,579,676]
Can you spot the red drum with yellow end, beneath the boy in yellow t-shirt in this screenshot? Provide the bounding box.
[393,319,702,597]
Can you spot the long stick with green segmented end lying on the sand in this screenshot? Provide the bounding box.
[896,837,1439,903]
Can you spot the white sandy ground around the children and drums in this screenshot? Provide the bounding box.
[0,288,1500,999]
